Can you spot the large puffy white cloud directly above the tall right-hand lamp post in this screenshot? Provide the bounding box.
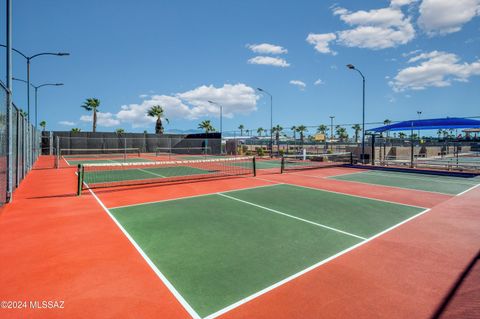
[334,7,415,50]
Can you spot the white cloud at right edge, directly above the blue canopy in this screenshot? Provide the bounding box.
[389,51,480,92]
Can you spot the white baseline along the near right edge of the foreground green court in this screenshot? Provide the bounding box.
[204,208,430,319]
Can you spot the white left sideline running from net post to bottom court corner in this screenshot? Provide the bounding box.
[88,188,201,319]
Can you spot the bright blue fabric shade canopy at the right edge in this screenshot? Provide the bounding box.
[368,117,480,133]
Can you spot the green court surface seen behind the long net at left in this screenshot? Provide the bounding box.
[84,166,215,184]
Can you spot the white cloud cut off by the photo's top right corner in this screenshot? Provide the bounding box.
[418,0,480,35]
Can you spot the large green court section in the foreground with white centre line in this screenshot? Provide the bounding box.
[110,185,423,317]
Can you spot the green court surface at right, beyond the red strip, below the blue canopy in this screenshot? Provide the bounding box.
[329,170,480,195]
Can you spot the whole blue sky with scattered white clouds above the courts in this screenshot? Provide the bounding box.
[0,0,480,132]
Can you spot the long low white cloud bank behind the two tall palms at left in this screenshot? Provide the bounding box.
[80,83,258,128]
